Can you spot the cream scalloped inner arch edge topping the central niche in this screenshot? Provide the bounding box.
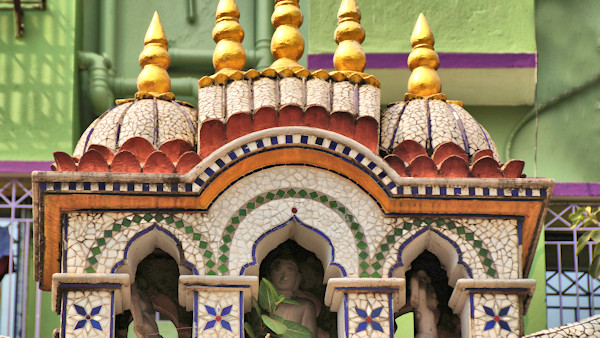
[240,216,347,283]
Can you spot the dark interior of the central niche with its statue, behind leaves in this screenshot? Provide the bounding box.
[249,240,337,338]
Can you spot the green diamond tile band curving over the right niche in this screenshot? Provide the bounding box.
[371,218,498,277]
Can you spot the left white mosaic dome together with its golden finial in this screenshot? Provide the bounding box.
[73,12,197,158]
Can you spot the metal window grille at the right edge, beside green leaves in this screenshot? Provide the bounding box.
[544,202,600,327]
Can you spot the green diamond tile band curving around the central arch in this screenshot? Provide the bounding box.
[213,188,372,277]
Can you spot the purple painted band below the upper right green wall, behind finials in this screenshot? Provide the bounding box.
[307,53,537,69]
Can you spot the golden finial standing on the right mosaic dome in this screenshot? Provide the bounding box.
[405,13,442,99]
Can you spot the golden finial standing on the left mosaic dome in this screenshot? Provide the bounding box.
[135,12,175,99]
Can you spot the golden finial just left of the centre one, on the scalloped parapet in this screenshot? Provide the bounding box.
[212,0,246,72]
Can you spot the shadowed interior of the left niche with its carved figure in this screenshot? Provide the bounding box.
[115,249,193,338]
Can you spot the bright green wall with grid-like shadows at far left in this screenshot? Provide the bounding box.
[0,0,78,161]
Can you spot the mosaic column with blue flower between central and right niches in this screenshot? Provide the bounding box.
[325,278,406,337]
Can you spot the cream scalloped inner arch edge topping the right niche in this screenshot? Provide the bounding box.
[388,228,473,287]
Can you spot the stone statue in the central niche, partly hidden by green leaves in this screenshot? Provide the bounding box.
[269,258,317,337]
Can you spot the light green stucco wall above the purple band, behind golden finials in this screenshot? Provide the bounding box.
[308,0,536,54]
